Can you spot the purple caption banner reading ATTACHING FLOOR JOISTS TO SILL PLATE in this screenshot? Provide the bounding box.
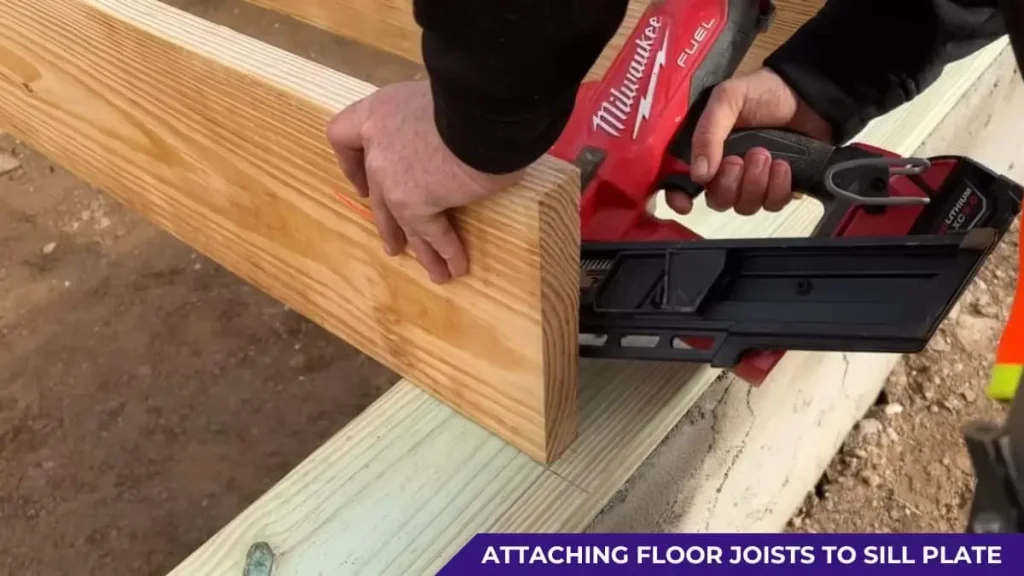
[440,534,1024,576]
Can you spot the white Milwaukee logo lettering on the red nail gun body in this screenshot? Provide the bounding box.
[592,16,669,138]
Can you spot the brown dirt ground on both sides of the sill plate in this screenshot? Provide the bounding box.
[0,0,1018,576]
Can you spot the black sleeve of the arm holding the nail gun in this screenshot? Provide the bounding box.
[764,0,1006,141]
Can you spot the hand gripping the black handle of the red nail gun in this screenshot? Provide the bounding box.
[666,68,831,215]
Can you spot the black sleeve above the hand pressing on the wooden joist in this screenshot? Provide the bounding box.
[413,0,628,173]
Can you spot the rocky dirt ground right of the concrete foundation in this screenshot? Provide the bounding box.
[790,213,1020,532]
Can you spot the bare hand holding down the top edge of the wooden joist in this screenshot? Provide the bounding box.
[328,81,521,284]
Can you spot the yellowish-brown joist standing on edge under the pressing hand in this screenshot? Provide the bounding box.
[0,0,579,461]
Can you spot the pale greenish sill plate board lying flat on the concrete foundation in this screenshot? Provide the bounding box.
[159,17,1007,576]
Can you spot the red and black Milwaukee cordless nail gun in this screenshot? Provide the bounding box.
[551,0,1024,385]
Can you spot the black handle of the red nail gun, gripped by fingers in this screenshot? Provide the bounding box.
[660,128,836,202]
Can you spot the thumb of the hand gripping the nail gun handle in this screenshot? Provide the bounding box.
[690,80,746,184]
